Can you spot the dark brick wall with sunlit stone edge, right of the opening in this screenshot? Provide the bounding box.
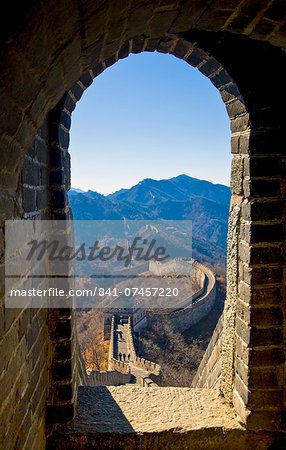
[184,31,285,430]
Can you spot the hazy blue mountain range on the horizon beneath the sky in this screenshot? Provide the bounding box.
[69,175,231,263]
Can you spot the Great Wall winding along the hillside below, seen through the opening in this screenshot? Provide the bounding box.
[79,259,216,387]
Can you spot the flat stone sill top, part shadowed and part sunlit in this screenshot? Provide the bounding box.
[66,384,243,433]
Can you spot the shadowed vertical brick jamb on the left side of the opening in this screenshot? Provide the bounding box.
[46,102,78,432]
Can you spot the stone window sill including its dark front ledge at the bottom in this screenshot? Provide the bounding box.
[47,384,277,450]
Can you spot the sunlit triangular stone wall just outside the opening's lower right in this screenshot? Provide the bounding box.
[192,316,223,389]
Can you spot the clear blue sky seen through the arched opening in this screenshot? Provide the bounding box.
[70,52,231,194]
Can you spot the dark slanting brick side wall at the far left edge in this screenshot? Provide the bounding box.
[0,123,50,449]
